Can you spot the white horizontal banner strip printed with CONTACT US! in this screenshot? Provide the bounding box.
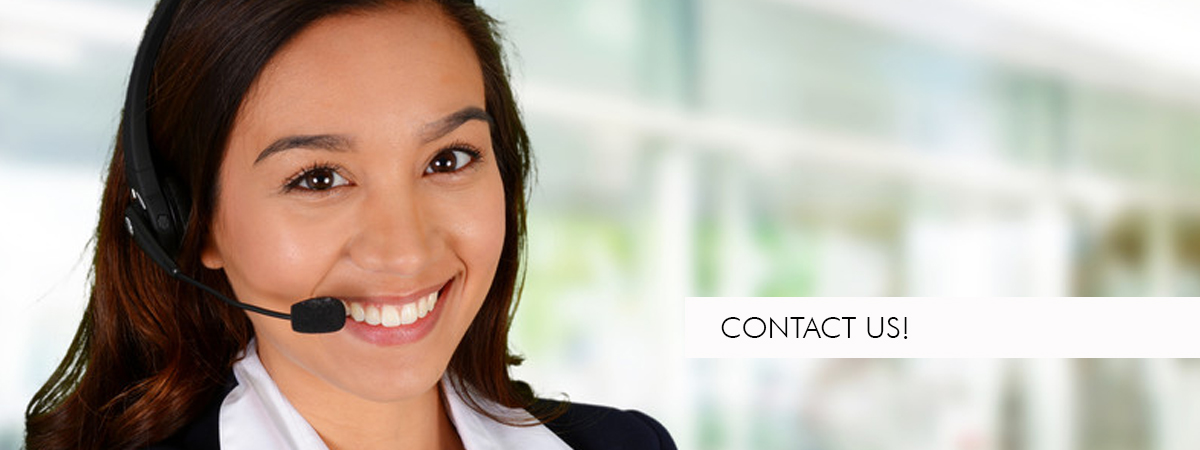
[684,298,1200,358]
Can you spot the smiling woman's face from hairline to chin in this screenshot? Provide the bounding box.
[203,5,505,402]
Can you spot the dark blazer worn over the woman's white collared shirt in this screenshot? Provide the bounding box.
[149,388,676,450]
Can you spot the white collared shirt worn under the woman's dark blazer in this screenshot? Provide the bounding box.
[218,341,570,450]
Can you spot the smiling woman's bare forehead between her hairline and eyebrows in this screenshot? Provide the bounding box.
[234,4,484,146]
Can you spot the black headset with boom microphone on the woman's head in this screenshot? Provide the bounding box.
[121,0,346,334]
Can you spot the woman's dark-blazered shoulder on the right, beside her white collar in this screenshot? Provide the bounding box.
[530,400,676,450]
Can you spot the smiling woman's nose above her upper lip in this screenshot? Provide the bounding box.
[348,184,437,276]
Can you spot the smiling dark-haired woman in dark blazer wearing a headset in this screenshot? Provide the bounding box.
[26,0,673,449]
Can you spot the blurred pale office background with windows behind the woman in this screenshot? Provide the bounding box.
[0,0,1200,450]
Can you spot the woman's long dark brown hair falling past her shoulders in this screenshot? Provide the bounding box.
[25,0,534,449]
